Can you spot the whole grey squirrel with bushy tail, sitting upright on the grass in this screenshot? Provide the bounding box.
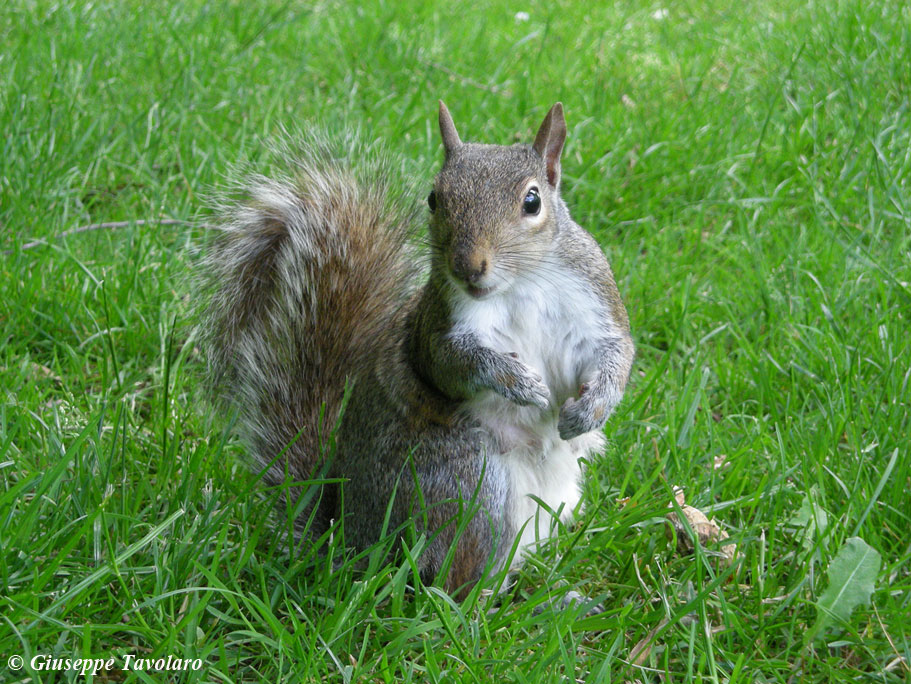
[204,102,634,593]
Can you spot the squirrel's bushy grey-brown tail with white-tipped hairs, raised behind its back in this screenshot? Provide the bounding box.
[203,132,418,523]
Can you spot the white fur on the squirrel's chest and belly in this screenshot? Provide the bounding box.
[454,268,609,560]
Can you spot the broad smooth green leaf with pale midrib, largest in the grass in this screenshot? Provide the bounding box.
[807,537,882,643]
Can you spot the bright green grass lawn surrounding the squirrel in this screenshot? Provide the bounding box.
[0,0,911,682]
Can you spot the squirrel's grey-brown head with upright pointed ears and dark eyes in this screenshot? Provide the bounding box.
[427,102,566,299]
